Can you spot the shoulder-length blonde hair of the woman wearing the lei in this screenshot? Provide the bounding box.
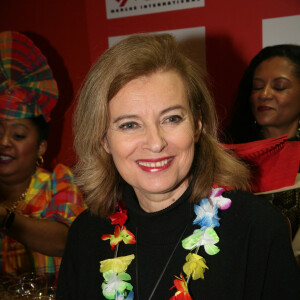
[74,34,249,217]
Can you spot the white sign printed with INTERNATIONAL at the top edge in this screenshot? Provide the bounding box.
[105,0,205,19]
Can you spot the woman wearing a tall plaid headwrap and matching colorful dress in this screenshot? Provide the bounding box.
[0,31,83,275]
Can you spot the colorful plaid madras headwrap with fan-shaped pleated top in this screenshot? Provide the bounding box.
[0,31,58,122]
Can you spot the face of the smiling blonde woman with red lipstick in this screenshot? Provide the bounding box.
[103,71,201,211]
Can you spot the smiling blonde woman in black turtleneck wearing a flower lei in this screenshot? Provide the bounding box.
[57,34,300,300]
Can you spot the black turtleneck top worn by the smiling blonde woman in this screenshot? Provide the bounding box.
[57,186,300,300]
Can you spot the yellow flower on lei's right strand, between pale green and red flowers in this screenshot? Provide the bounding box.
[183,253,208,280]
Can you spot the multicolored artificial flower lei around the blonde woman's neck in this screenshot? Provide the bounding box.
[100,187,231,300]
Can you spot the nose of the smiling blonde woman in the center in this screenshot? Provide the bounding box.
[143,126,167,153]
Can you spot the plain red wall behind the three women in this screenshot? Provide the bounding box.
[0,0,300,169]
